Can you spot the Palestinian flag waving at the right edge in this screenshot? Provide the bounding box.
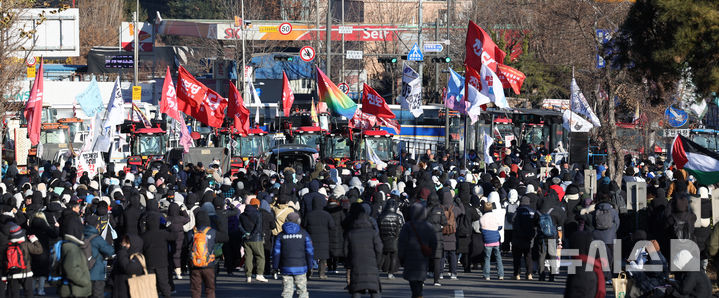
[672,135,719,185]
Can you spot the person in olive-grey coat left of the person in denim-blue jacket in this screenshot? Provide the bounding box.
[58,215,92,297]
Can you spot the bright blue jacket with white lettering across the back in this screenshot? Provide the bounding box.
[272,222,315,275]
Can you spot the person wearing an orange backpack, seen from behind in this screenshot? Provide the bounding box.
[189,209,217,297]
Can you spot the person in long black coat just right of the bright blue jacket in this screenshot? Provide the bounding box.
[303,199,335,279]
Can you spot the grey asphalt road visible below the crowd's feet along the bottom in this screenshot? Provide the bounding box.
[166,257,614,298]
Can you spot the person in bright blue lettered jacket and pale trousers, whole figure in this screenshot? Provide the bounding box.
[272,212,314,298]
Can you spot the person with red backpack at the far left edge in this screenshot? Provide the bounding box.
[4,222,42,297]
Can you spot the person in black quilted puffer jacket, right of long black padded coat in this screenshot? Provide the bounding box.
[379,199,404,279]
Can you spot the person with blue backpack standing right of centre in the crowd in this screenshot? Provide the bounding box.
[535,185,567,281]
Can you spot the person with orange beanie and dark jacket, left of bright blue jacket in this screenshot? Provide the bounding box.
[239,196,268,283]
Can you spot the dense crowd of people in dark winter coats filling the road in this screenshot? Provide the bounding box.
[0,140,719,297]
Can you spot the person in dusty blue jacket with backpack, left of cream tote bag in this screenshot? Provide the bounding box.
[83,215,115,298]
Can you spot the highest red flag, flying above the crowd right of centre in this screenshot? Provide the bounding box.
[464,21,507,72]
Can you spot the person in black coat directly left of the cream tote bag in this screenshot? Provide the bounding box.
[110,234,147,298]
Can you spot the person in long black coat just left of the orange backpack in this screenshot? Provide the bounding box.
[142,213,177,297]
